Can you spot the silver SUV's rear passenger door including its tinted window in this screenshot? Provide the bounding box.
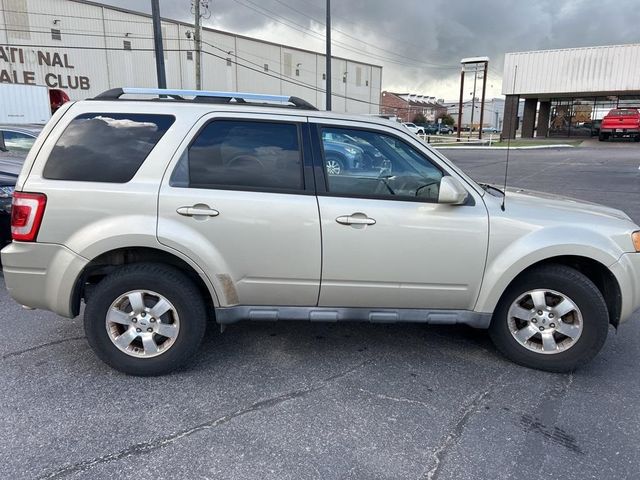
[158,113,321,306]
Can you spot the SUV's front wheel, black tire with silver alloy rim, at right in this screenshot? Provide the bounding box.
[489,265,609,372]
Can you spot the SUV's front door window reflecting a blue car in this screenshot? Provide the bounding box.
[322,128,443,202]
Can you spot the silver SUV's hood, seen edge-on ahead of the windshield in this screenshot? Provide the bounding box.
[506,188,632,221]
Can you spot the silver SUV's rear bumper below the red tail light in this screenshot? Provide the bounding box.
[2,242,88,318]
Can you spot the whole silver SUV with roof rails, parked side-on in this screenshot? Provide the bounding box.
[2,89,640,375]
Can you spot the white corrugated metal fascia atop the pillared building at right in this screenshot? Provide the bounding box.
[502,44,640,95]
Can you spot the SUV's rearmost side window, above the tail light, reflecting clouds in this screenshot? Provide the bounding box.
[43,113,175,183]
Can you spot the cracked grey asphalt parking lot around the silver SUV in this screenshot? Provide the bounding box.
[0,142,640,480]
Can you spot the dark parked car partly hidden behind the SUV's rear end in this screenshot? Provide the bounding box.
[0,125,42,248]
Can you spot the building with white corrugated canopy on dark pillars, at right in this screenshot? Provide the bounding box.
[502,44,640,138]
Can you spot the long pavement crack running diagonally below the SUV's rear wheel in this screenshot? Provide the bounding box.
[38,361,369,480]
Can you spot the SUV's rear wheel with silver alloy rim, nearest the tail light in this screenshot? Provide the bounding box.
[84,263,207,376]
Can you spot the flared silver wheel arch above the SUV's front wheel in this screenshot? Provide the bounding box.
[474,226,624,313]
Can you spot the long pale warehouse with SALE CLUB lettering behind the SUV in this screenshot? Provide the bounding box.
[0,0,382,113]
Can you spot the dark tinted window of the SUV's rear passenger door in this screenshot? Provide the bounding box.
[171,120,304,190]
